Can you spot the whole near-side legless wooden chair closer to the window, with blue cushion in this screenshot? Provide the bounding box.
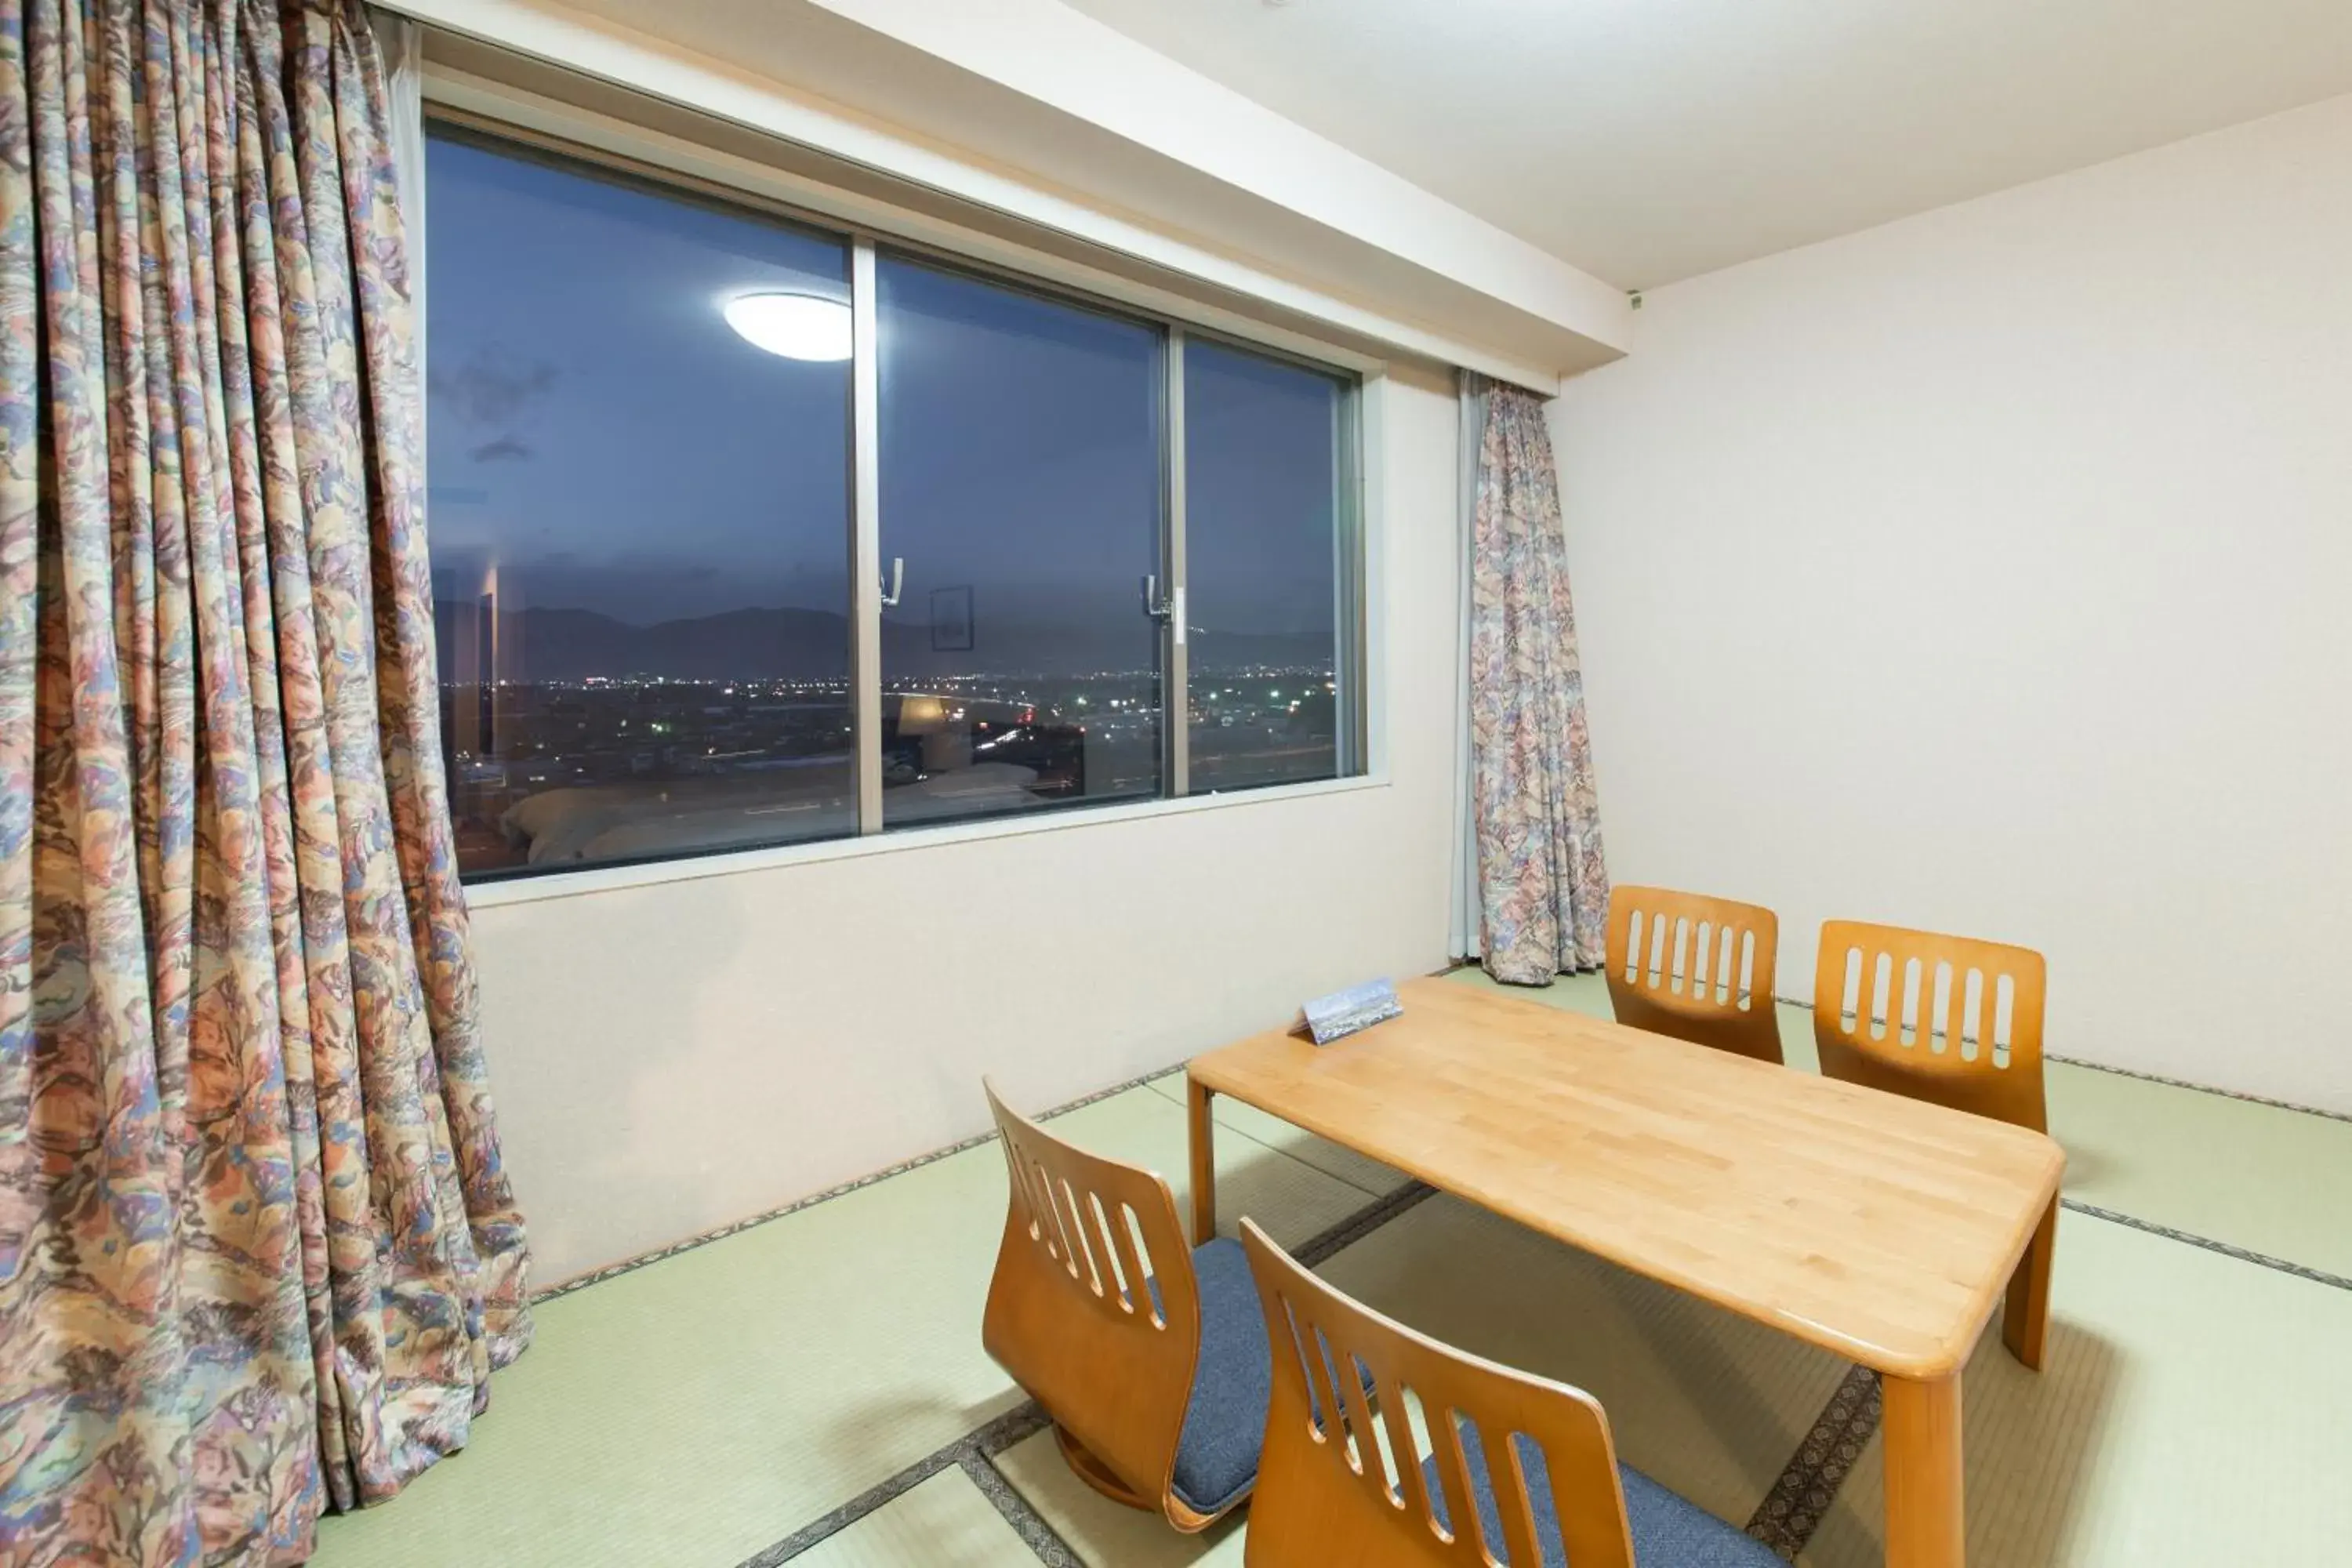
[981,1083,1270,1533]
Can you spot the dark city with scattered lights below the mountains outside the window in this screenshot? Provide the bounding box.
[442,648,1336,872]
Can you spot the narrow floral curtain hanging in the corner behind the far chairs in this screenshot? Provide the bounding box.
[1470,383,1609,985]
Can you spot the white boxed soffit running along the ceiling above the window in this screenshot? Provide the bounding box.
[388,0,1632,386]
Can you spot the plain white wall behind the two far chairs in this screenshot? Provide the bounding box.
[1555,99,2352,1109]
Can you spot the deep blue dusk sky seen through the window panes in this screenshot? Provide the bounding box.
[426,132,1341,668]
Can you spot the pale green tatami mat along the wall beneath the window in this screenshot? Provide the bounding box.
[315,1088,1367,1568]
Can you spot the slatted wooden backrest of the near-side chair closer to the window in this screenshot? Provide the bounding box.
[981,1083,1200,1528]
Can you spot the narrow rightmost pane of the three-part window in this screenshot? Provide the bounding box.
[1183,336,1357,794]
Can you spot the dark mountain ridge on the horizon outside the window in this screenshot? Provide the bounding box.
[433,600,1331,682]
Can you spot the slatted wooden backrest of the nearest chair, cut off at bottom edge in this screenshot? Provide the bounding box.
[1242,1220,1632,1568]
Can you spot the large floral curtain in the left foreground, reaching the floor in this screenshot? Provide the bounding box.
[0,0,529,1566]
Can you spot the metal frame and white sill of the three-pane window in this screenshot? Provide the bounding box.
[419,95,1388,907]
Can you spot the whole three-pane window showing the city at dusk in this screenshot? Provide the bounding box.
[426,122,1362,879]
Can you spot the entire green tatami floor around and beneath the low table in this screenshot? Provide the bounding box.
[313,971,2352,1568]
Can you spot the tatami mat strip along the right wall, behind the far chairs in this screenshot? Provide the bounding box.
[1454,968,2352,1279]
